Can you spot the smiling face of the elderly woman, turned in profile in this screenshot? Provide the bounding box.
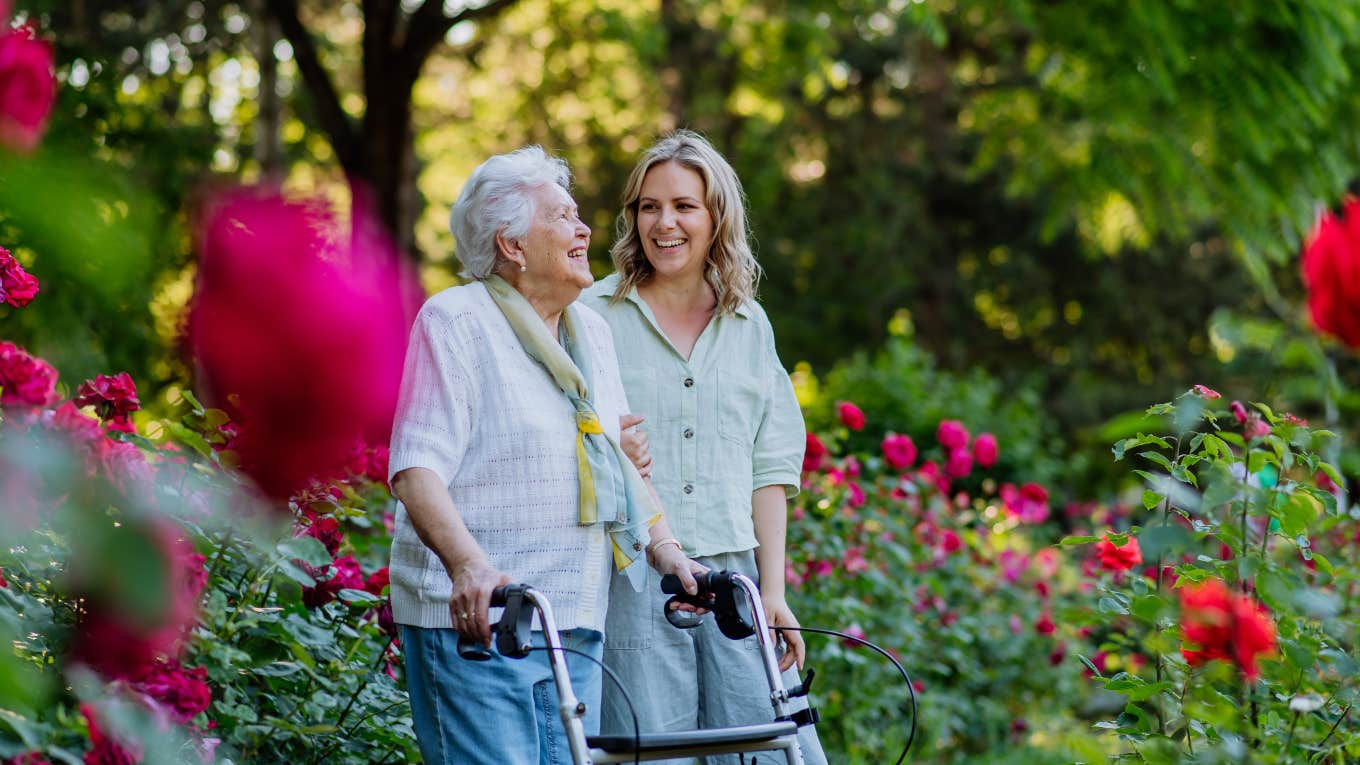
[499,185,594,310]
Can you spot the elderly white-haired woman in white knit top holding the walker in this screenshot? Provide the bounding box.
[390,147,702,765]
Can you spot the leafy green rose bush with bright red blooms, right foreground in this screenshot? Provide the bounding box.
[1070,393,1360,762]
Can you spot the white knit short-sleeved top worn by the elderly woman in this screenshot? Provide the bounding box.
[389,283,628,630]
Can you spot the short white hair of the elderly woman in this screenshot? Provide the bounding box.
[449,146,571,282]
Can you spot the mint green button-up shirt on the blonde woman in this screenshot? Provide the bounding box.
[581,274,806,555]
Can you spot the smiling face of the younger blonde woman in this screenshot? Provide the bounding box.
[638,162,714,282]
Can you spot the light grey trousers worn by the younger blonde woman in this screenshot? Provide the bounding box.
[600,550,827,765]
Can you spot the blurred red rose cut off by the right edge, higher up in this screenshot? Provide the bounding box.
[1300,199,1360,348]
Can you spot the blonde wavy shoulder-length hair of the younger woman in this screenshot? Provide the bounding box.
[609,129,760,314]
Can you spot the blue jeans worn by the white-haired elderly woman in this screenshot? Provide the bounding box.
[401,625,604,765]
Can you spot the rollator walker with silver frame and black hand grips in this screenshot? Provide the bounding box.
[458,572,819,765]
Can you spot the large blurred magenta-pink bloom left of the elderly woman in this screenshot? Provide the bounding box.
[188,189,423,500]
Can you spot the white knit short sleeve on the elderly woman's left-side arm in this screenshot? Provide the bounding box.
[388,305,475,486]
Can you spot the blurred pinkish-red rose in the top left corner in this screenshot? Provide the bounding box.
[0,26,57,151]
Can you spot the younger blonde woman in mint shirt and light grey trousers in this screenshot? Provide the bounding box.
[582,131,826,765]
